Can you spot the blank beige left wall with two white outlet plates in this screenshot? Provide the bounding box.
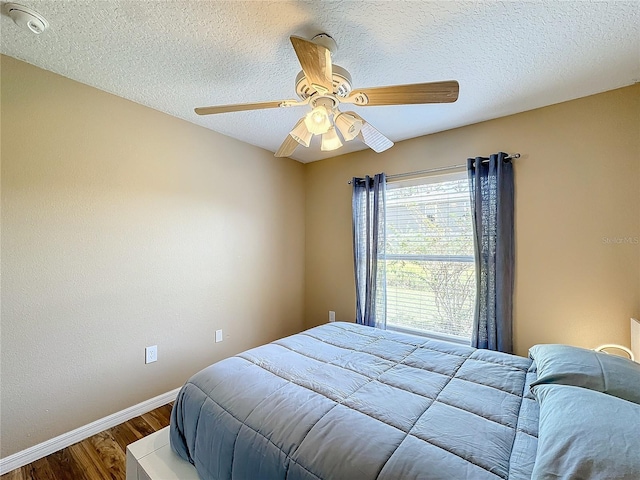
[0,56,304,458]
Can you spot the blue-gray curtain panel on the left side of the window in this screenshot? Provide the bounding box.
[351,173,387,328]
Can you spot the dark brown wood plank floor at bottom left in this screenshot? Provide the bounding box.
[0,403,173,480]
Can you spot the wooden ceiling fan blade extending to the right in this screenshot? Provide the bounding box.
[340,80,460,106]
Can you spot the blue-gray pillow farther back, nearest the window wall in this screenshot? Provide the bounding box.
[529,344,640,404]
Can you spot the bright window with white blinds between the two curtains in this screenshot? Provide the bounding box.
[385,173,475,339]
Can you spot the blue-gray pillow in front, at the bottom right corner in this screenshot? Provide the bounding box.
[531,384,640,480]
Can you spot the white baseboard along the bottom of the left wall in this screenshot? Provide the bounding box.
[0,388,180,475]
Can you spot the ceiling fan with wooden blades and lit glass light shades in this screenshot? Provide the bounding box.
[195,33,459,157]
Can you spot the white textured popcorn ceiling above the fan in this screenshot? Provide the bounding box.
[1,0,640,162]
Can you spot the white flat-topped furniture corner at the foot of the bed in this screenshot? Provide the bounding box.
[127,427,200,480]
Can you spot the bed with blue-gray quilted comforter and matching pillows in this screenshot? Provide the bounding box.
[170,322,640,480]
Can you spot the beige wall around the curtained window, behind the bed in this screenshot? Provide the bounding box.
[305,85,640,355]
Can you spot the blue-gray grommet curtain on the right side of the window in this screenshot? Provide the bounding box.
[467,153,514,353]
